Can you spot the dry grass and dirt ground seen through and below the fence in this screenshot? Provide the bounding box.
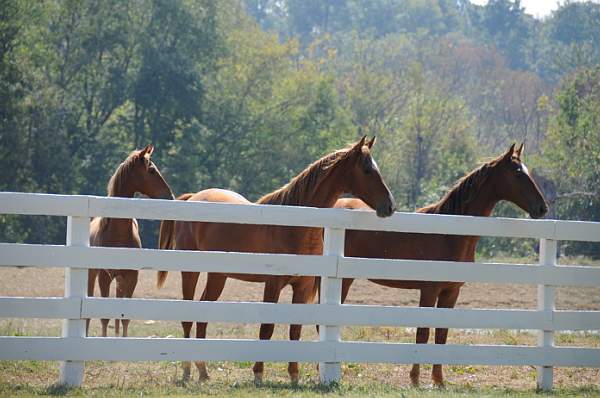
[0,259,600,397]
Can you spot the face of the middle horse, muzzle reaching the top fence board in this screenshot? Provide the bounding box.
[347,137,396,217]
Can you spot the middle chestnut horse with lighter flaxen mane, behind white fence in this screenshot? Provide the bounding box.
[157,137,395,383]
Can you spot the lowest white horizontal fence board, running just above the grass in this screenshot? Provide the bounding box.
[0,337,600,367]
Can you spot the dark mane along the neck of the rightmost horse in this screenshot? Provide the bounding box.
[417,155,504,215]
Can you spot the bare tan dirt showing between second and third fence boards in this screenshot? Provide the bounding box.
[0,262,600,310]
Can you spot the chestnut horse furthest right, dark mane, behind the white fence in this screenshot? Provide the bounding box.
[335,144,548,386]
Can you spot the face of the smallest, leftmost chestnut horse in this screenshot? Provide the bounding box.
[133,145,174,199]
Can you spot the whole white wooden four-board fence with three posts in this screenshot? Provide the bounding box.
[0,192,600,389]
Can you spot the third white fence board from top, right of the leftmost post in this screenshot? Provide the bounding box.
[82,298,600,330]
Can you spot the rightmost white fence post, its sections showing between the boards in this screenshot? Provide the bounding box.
[537,239,557,391]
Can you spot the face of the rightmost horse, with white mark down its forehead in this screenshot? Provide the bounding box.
[496,144,548,218]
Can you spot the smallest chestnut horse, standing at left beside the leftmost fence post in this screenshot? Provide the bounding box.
[86,145,173,337]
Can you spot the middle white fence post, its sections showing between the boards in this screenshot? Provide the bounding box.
[319,228,345,384]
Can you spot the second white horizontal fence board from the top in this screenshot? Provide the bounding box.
[0,243,600,286]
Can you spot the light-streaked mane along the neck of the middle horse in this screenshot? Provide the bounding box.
[256,145,352,206]
